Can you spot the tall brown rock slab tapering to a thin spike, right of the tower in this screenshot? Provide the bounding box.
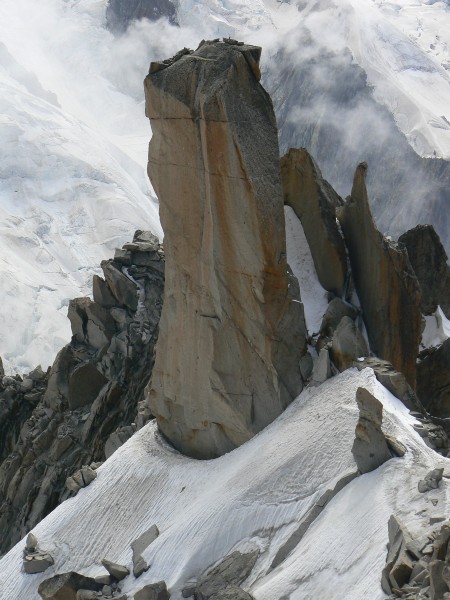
[338,163,422,389]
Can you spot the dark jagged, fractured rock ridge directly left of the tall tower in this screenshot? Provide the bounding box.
[0,231,164,553]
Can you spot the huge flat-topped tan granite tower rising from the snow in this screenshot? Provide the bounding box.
[145,41,307,459]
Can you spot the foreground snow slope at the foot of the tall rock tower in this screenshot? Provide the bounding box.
[0,369,450,600]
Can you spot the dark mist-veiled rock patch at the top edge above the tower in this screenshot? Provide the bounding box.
[106,0,177,33]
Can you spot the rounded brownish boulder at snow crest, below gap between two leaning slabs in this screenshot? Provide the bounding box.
[330,317,369,371]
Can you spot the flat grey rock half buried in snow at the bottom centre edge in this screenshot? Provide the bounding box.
[195,550,259,600]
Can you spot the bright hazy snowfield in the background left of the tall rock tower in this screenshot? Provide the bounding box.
[0,0,161,370]
